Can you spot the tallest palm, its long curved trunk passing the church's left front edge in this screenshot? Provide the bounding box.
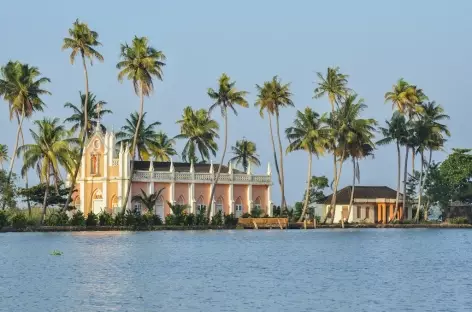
[62,19,104,209]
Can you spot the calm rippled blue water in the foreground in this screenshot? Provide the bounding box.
[0,229,472,312]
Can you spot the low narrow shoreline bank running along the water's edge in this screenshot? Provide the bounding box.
[0,223,472,233]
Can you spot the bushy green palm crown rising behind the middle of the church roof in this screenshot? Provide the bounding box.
[175,106,219,163]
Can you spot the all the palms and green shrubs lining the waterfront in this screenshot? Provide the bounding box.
[0,20,464,226]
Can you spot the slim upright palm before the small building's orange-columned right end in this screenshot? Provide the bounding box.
[377,112,408,221]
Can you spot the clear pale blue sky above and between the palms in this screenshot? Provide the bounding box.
[0,0,472,204]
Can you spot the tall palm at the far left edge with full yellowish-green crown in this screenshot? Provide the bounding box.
[0,62,51,209]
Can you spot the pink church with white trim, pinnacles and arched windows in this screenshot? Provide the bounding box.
[73,128,272,219]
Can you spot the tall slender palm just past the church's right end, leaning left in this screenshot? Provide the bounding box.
[255,76,294,208]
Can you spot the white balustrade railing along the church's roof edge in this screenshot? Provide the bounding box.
[133,170,272,185]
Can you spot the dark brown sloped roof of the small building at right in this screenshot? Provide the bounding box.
[323,185,403,205]
